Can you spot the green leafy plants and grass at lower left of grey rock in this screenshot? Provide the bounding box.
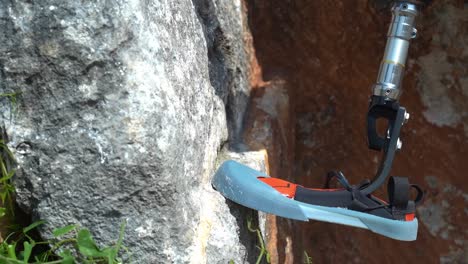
[0,104,131,264]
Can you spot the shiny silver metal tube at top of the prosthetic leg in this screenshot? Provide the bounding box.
[372,2,418,100]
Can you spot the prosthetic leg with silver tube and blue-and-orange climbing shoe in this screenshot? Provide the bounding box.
[212,1,423,241]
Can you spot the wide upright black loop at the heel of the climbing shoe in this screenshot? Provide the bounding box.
[387,176,411,210]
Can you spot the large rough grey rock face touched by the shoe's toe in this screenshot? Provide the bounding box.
[0,0,261,263]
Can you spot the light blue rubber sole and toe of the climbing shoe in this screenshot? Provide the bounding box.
[212,160,418,241]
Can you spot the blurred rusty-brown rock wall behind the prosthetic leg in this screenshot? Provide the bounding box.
[245,0,468,263]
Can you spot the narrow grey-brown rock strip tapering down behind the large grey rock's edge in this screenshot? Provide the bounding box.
[192,0,250,145]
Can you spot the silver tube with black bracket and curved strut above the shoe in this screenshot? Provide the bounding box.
[363,1,418,194]
